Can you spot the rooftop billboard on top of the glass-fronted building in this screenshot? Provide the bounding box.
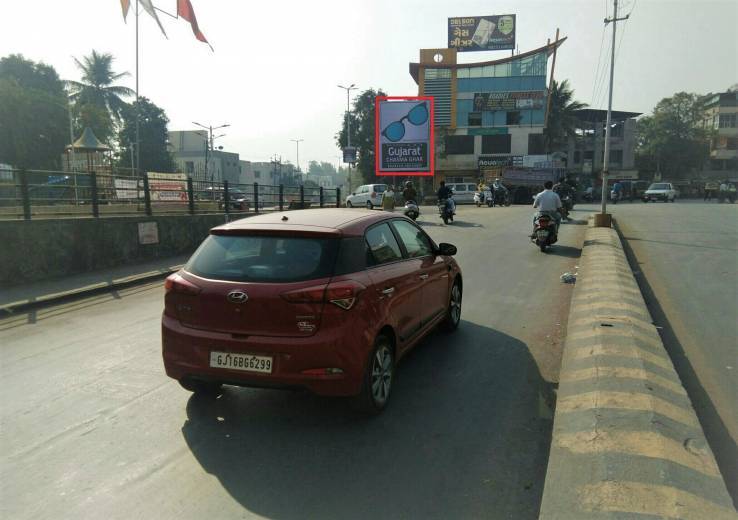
[448,14,515,52]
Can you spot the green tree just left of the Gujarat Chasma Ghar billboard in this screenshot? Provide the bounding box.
[336,89,386,187]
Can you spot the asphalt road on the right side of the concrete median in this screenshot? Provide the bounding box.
[592,201,738,503]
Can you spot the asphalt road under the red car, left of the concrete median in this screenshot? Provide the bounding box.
[0,207,585,520]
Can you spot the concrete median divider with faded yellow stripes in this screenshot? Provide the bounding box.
[540,228,738,520]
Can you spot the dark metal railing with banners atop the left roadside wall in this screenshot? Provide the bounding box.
[0,169,341,220]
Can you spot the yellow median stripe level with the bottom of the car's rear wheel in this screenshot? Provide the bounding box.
[556,390,701,431]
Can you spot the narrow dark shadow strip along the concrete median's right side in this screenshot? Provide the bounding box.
[621,233,738,508]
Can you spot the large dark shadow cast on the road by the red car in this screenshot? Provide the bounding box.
[182,322,553,519]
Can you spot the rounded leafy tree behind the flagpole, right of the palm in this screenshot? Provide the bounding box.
[118,96,176,176]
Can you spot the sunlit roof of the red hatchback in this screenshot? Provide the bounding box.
[211,208,400,235]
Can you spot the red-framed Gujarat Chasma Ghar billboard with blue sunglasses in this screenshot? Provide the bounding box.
[374,96,434,176]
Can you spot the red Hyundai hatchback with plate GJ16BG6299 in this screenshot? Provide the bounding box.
[162,209,463,413]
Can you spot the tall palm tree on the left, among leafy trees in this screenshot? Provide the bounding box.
[67,50,135,141]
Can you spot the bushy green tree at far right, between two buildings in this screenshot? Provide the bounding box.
[636,92,710,178]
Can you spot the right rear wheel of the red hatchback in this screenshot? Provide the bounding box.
[354,334,395,415]
